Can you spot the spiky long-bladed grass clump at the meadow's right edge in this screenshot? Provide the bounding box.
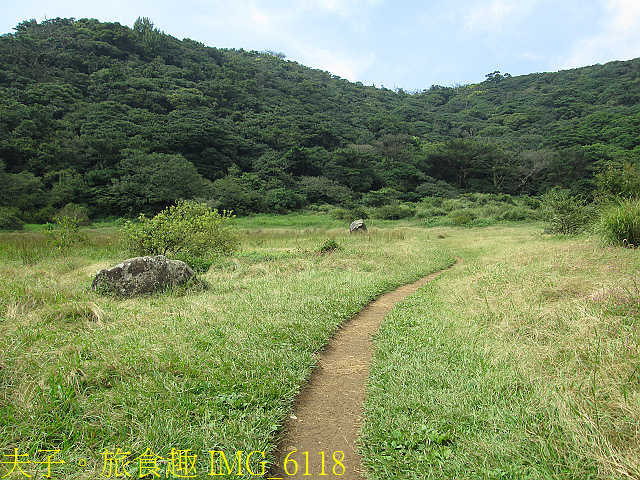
[598,199,640,248]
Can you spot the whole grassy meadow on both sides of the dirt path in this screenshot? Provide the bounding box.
[0,215,640,479]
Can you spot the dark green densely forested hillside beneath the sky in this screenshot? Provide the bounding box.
[0,18,640,221]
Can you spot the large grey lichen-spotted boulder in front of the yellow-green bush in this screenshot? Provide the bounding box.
[91,255,195,297]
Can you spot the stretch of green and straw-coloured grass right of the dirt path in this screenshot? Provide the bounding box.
[362,226,640,479]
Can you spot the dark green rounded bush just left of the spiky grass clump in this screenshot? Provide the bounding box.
[542,187,595,235]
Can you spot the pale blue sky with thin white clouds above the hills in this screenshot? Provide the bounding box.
[0,0,640,92]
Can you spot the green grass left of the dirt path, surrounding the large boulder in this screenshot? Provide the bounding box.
[0,223,453,479]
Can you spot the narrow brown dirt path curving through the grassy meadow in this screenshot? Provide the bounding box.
[266,260,460,480]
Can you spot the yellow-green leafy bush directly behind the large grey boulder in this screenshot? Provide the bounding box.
[121,201,239,270]
